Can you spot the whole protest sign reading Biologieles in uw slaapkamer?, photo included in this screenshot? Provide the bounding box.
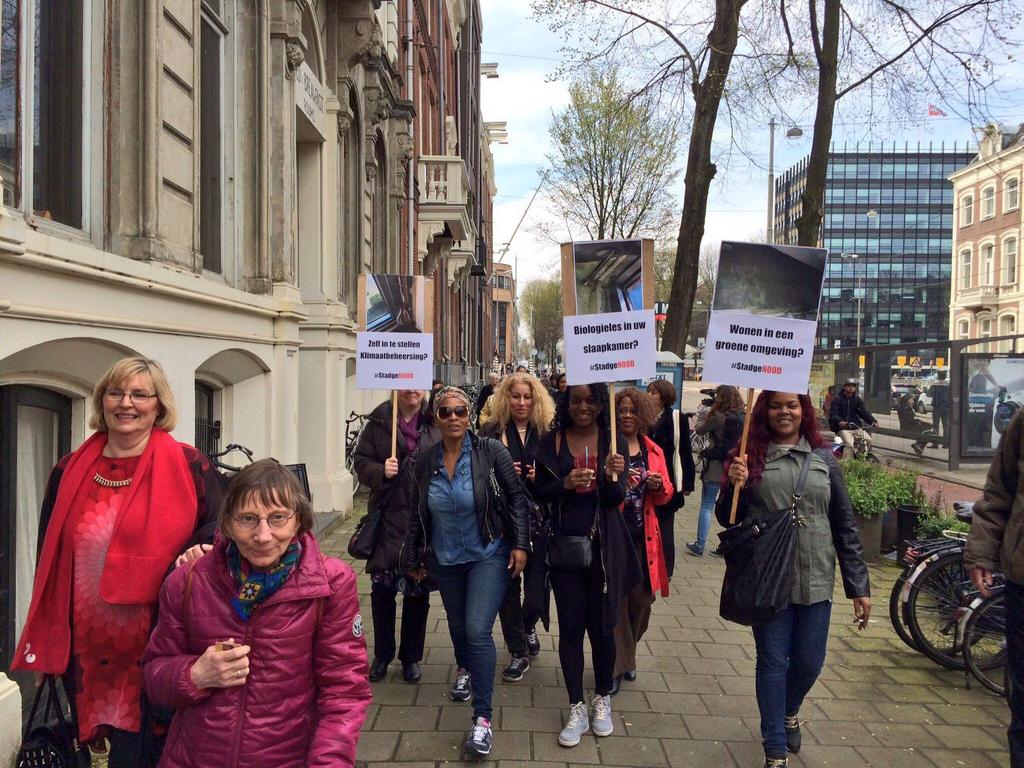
[562,240,655,384]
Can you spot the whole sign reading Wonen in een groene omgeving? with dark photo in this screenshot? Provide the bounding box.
[702,243,827,393]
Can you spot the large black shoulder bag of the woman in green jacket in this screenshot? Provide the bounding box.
[718,454,811,627]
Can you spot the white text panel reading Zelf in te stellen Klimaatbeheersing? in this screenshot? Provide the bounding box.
[355,332,434,389]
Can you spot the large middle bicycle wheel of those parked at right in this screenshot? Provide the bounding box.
[903,549,974,670]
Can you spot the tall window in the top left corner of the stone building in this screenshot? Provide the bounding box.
[0,0,87,229]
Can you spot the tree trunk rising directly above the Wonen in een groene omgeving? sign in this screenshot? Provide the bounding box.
[797,0,843,246]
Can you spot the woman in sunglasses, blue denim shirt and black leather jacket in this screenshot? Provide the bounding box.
[402,387,529,760]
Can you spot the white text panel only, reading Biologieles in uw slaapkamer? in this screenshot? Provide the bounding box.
[562,309,656,384]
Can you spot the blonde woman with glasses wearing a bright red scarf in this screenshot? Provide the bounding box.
[11,357,223,768]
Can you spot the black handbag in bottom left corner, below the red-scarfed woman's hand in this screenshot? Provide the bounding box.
[14,675,89,768]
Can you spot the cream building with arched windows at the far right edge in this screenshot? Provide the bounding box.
[949,124,1024,352]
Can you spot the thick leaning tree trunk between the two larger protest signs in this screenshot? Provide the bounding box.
[662,0,746,357]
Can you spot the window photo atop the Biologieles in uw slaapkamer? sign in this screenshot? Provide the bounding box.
[572,240,644,314]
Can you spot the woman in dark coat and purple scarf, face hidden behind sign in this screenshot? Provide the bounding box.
[354,389,440,683]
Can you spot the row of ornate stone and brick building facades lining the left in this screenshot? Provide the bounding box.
[0,0,494,745]
